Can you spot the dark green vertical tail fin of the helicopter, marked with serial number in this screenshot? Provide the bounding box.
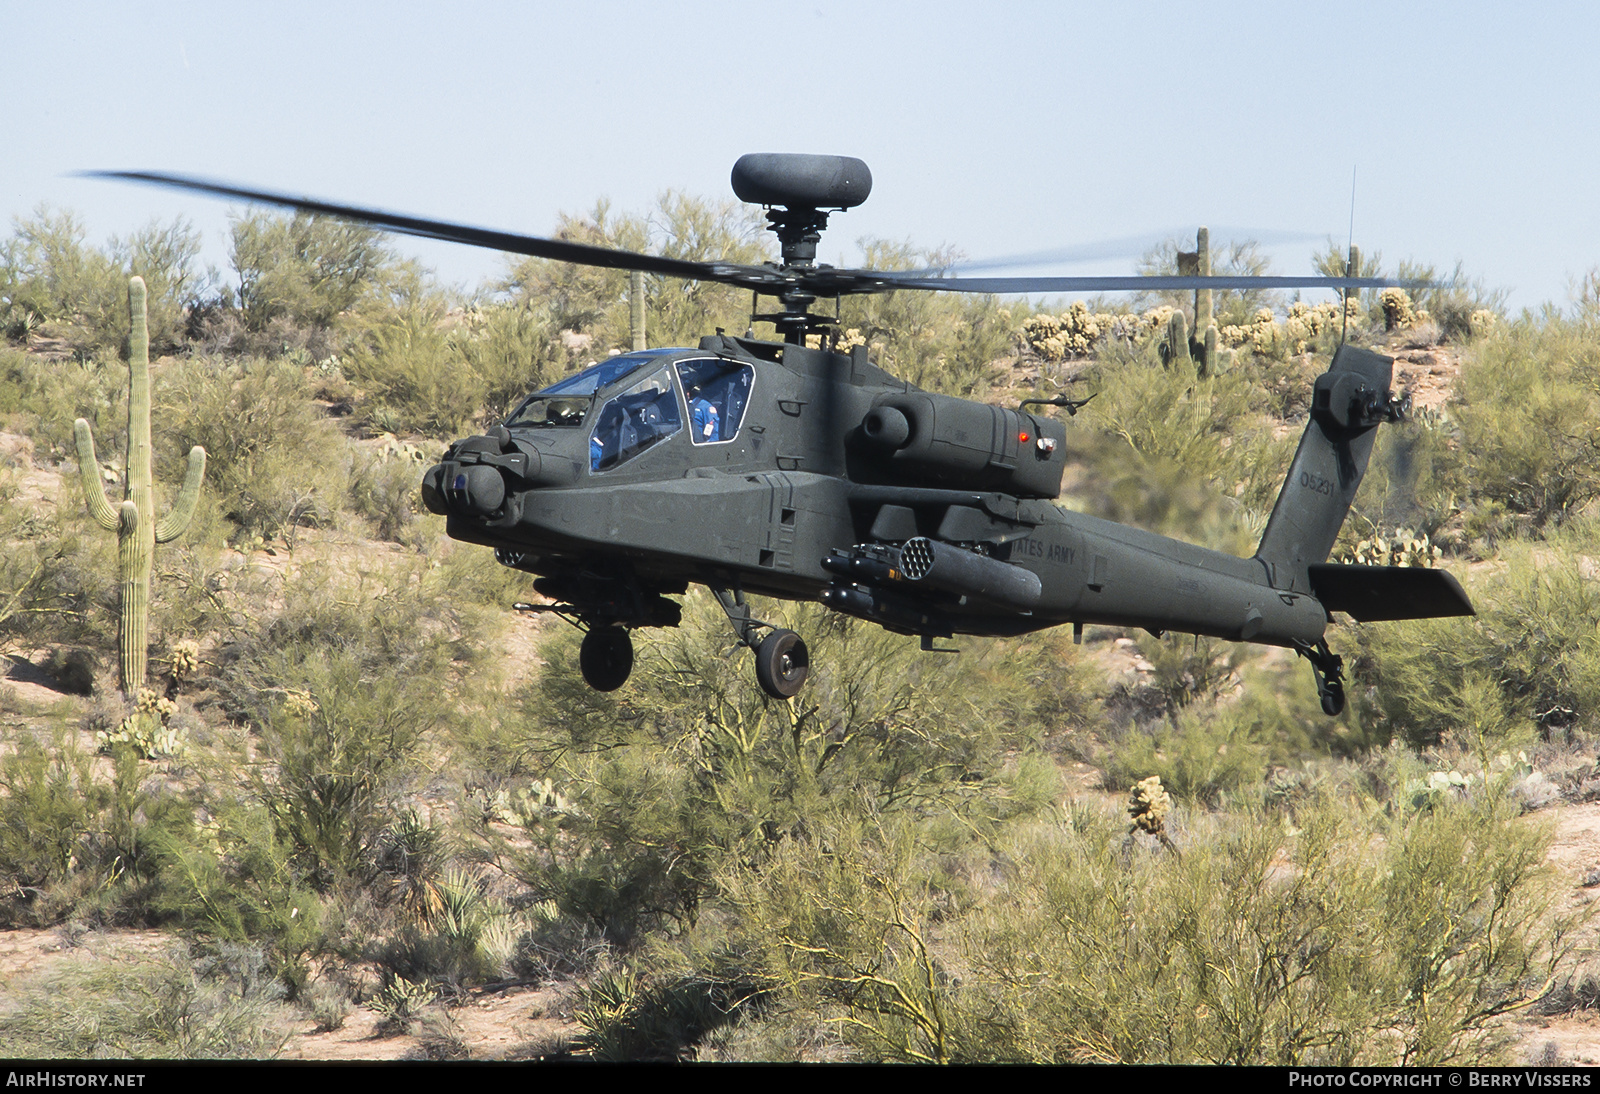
[1256,345,1403,593]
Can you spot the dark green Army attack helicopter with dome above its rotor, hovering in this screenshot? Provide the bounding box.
[98,154,1474,715]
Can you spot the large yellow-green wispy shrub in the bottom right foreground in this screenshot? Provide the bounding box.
[949,798,1570,1065]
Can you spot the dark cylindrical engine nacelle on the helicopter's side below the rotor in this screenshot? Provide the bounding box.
[861,392,1067,497]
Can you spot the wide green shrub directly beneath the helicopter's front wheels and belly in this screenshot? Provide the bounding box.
[505,595,1082,945]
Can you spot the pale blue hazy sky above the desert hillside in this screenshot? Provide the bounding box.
[0,0,1600,309]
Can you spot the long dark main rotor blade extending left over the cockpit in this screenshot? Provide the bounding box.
[83,171,770,286]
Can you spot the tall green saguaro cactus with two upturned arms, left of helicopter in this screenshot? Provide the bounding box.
[72,277,205,696]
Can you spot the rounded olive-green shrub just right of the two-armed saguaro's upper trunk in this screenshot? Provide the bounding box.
[150,358,349,537]
